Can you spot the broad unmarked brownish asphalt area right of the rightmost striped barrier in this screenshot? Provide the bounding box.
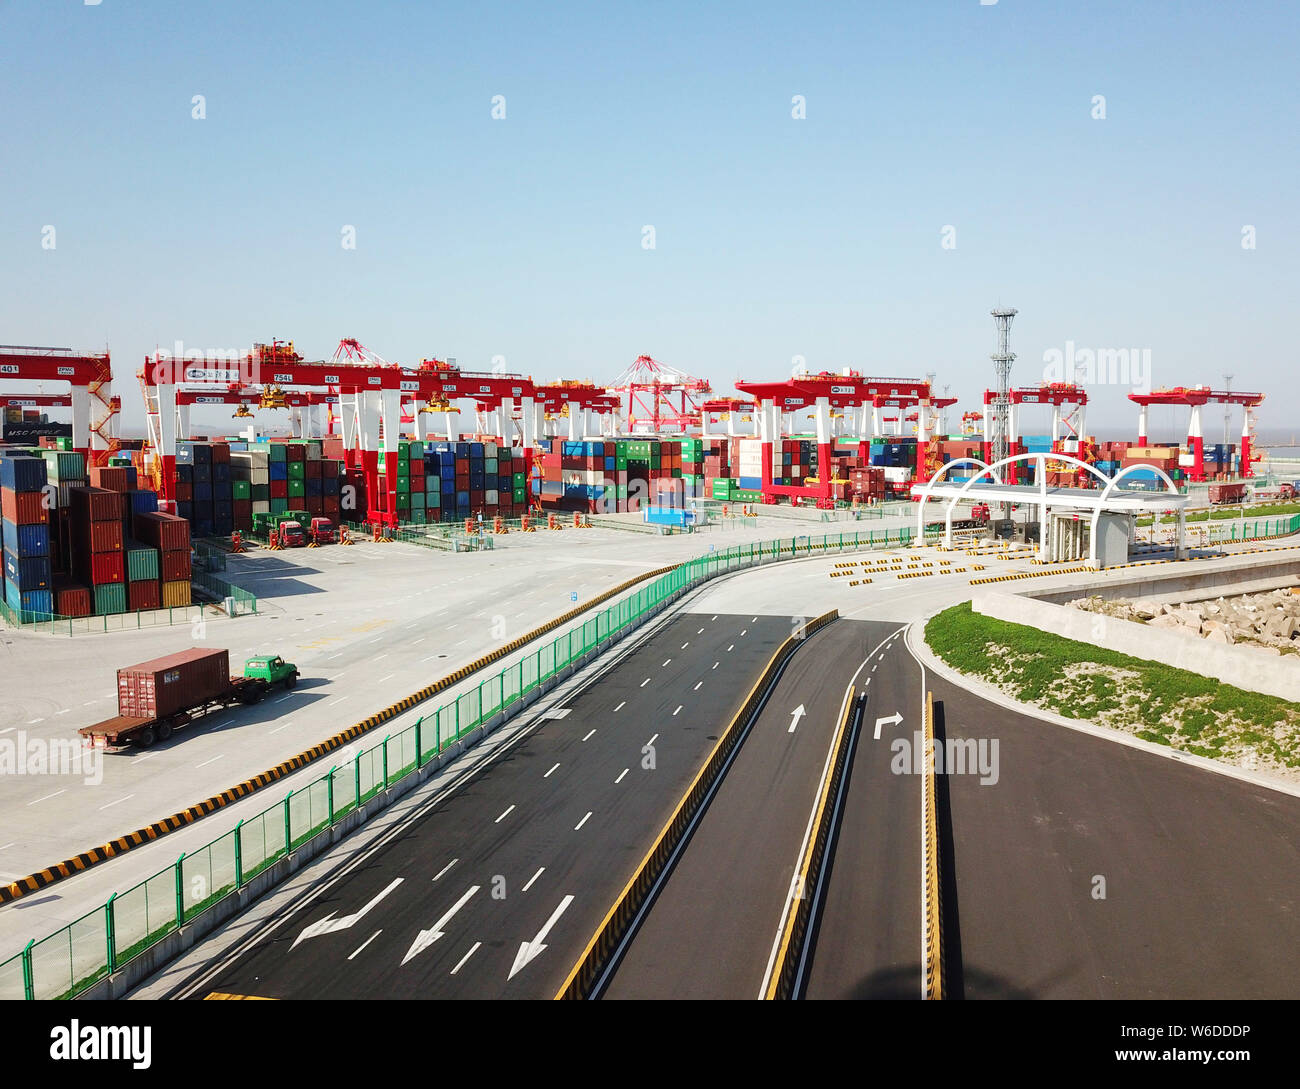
[932,681,1300,998]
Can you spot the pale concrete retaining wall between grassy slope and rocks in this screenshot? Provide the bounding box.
[971,587,1300,703]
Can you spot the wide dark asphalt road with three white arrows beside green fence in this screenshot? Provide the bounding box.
[162,613,789,998]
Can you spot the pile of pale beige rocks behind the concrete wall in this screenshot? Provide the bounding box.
[1066,590,1300,654]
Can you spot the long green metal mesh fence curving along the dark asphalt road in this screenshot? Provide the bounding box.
[0,528,913,1001]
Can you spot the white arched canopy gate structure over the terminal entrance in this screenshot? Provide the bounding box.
[914,454,1188,567]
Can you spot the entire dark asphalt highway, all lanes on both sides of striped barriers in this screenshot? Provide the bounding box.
[129,545,1300,999]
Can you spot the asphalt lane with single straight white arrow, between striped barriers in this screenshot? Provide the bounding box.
[603,620,884,999]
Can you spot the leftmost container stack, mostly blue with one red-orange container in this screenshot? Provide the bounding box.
[0,452,55,620]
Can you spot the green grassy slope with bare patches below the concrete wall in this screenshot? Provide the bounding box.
[926,602,1300,769]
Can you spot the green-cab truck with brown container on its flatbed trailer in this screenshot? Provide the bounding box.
[78,650,298,752]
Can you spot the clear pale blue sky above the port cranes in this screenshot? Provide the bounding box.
[0,0,1300,434]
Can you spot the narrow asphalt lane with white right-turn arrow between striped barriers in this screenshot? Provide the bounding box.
[803,624,923,999]
